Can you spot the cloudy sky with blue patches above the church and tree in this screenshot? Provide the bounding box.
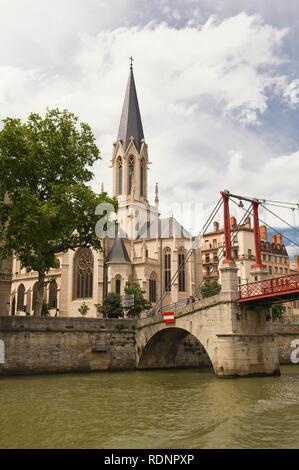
[0,0,299,246]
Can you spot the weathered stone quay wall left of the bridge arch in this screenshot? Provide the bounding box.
[0,317,136,375]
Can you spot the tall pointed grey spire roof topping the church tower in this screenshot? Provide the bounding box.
[117,62,144,151]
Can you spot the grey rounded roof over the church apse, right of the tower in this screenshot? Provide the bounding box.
[137,217,191,239]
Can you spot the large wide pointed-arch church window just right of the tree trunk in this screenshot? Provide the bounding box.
[73,248,93,299]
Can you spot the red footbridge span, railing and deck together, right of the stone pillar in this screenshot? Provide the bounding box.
[239,274,299,305]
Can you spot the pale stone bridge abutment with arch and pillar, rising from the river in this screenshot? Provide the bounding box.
[136,265,280,377]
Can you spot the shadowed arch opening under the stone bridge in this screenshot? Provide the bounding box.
[138,327,213,369]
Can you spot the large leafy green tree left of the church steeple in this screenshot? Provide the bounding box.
[0,109,116,315]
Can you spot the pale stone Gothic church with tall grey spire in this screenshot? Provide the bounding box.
[10,64,202,317]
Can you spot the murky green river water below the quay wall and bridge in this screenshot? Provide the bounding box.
[0,366,299,449]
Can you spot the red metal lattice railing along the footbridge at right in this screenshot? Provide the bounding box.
[239,274,299,300]
